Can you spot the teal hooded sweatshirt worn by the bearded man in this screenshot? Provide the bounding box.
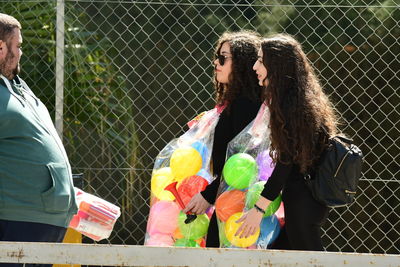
[0,76,77,227]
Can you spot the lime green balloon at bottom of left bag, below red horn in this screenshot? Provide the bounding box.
[178,212,210,240]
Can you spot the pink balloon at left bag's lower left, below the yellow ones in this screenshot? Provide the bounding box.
[147,201,180,236]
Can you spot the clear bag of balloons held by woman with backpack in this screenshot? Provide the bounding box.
[215,103,284,249]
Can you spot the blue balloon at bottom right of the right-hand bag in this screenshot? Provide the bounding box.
[257,215,281,249]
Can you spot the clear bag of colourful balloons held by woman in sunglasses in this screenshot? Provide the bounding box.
[144,106,224,247]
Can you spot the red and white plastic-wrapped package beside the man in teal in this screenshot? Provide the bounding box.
[69,187,121,241]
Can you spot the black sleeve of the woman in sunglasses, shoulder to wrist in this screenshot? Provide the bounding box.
[201,97,261,204]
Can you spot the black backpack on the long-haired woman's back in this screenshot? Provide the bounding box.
[304,136,363,207]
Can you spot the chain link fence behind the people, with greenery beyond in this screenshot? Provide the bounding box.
[0,0,400,254]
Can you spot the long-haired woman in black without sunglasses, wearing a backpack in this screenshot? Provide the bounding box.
[236,34,337,251]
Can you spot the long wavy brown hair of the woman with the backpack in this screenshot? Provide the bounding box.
[261,34,337,173]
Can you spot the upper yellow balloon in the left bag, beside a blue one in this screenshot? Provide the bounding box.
[170,146,203,181]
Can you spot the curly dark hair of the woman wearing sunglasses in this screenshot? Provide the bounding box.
[214,30,262,107]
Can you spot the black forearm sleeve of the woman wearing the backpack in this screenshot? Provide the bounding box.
[261,162,293,201]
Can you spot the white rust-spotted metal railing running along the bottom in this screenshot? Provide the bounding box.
[0,242,400,267]
